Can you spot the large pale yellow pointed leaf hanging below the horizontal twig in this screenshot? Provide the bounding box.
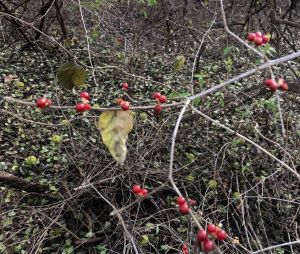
[98,111,133,165]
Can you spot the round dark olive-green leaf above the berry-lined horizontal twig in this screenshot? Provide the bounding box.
[57,62,86,90]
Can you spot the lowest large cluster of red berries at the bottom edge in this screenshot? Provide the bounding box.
[197,224,227,252]
